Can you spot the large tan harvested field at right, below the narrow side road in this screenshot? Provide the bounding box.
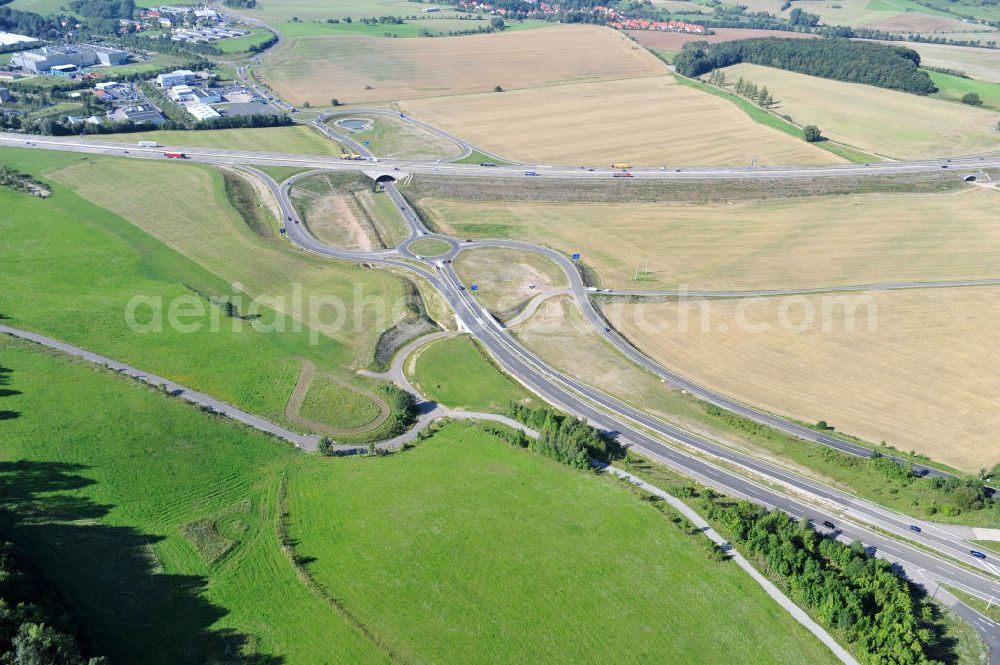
[604,287,1000,472]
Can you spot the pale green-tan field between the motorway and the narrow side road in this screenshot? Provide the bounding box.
[421,187,1000,290]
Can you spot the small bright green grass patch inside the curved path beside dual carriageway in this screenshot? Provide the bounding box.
[406,335,534,413]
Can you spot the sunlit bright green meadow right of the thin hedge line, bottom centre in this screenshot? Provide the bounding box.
[288,424,834,665]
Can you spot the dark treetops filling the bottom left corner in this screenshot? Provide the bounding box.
[0,542,107,665]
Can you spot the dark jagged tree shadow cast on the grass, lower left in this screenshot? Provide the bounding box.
[0,461,284,665]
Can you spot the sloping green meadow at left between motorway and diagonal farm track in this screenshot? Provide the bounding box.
[0,150,401,434]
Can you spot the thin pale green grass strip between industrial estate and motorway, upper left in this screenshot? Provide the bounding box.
[90,125,341,155]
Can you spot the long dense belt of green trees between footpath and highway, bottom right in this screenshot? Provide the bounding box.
[708,501,948,665]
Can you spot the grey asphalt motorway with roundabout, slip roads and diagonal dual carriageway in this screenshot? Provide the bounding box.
[0,116,1000,658]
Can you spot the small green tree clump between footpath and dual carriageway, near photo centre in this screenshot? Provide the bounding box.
[507,402,618,469]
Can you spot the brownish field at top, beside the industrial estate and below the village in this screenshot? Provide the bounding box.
[260,25,663,104]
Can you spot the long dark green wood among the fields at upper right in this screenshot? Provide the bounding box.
[674,37,937,95]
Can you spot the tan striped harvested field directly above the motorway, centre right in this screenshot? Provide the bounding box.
[401,75,842,166]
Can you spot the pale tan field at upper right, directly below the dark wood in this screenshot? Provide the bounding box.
[722,64,1000,159]
